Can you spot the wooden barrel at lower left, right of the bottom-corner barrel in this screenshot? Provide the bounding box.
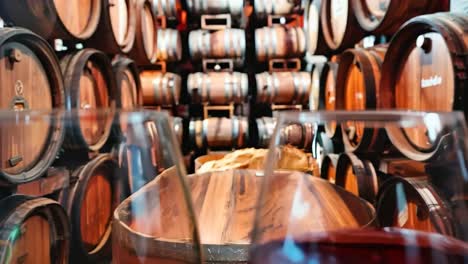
[59,154,120,263]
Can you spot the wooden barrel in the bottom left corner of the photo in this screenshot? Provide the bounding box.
[0,195,70,264]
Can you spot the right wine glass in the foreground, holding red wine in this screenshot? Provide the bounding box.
[249,111,468,263]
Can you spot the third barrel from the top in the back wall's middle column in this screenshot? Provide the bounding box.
[187,72,249,105]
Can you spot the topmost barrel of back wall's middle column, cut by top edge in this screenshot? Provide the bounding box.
[186,0,245,18]
